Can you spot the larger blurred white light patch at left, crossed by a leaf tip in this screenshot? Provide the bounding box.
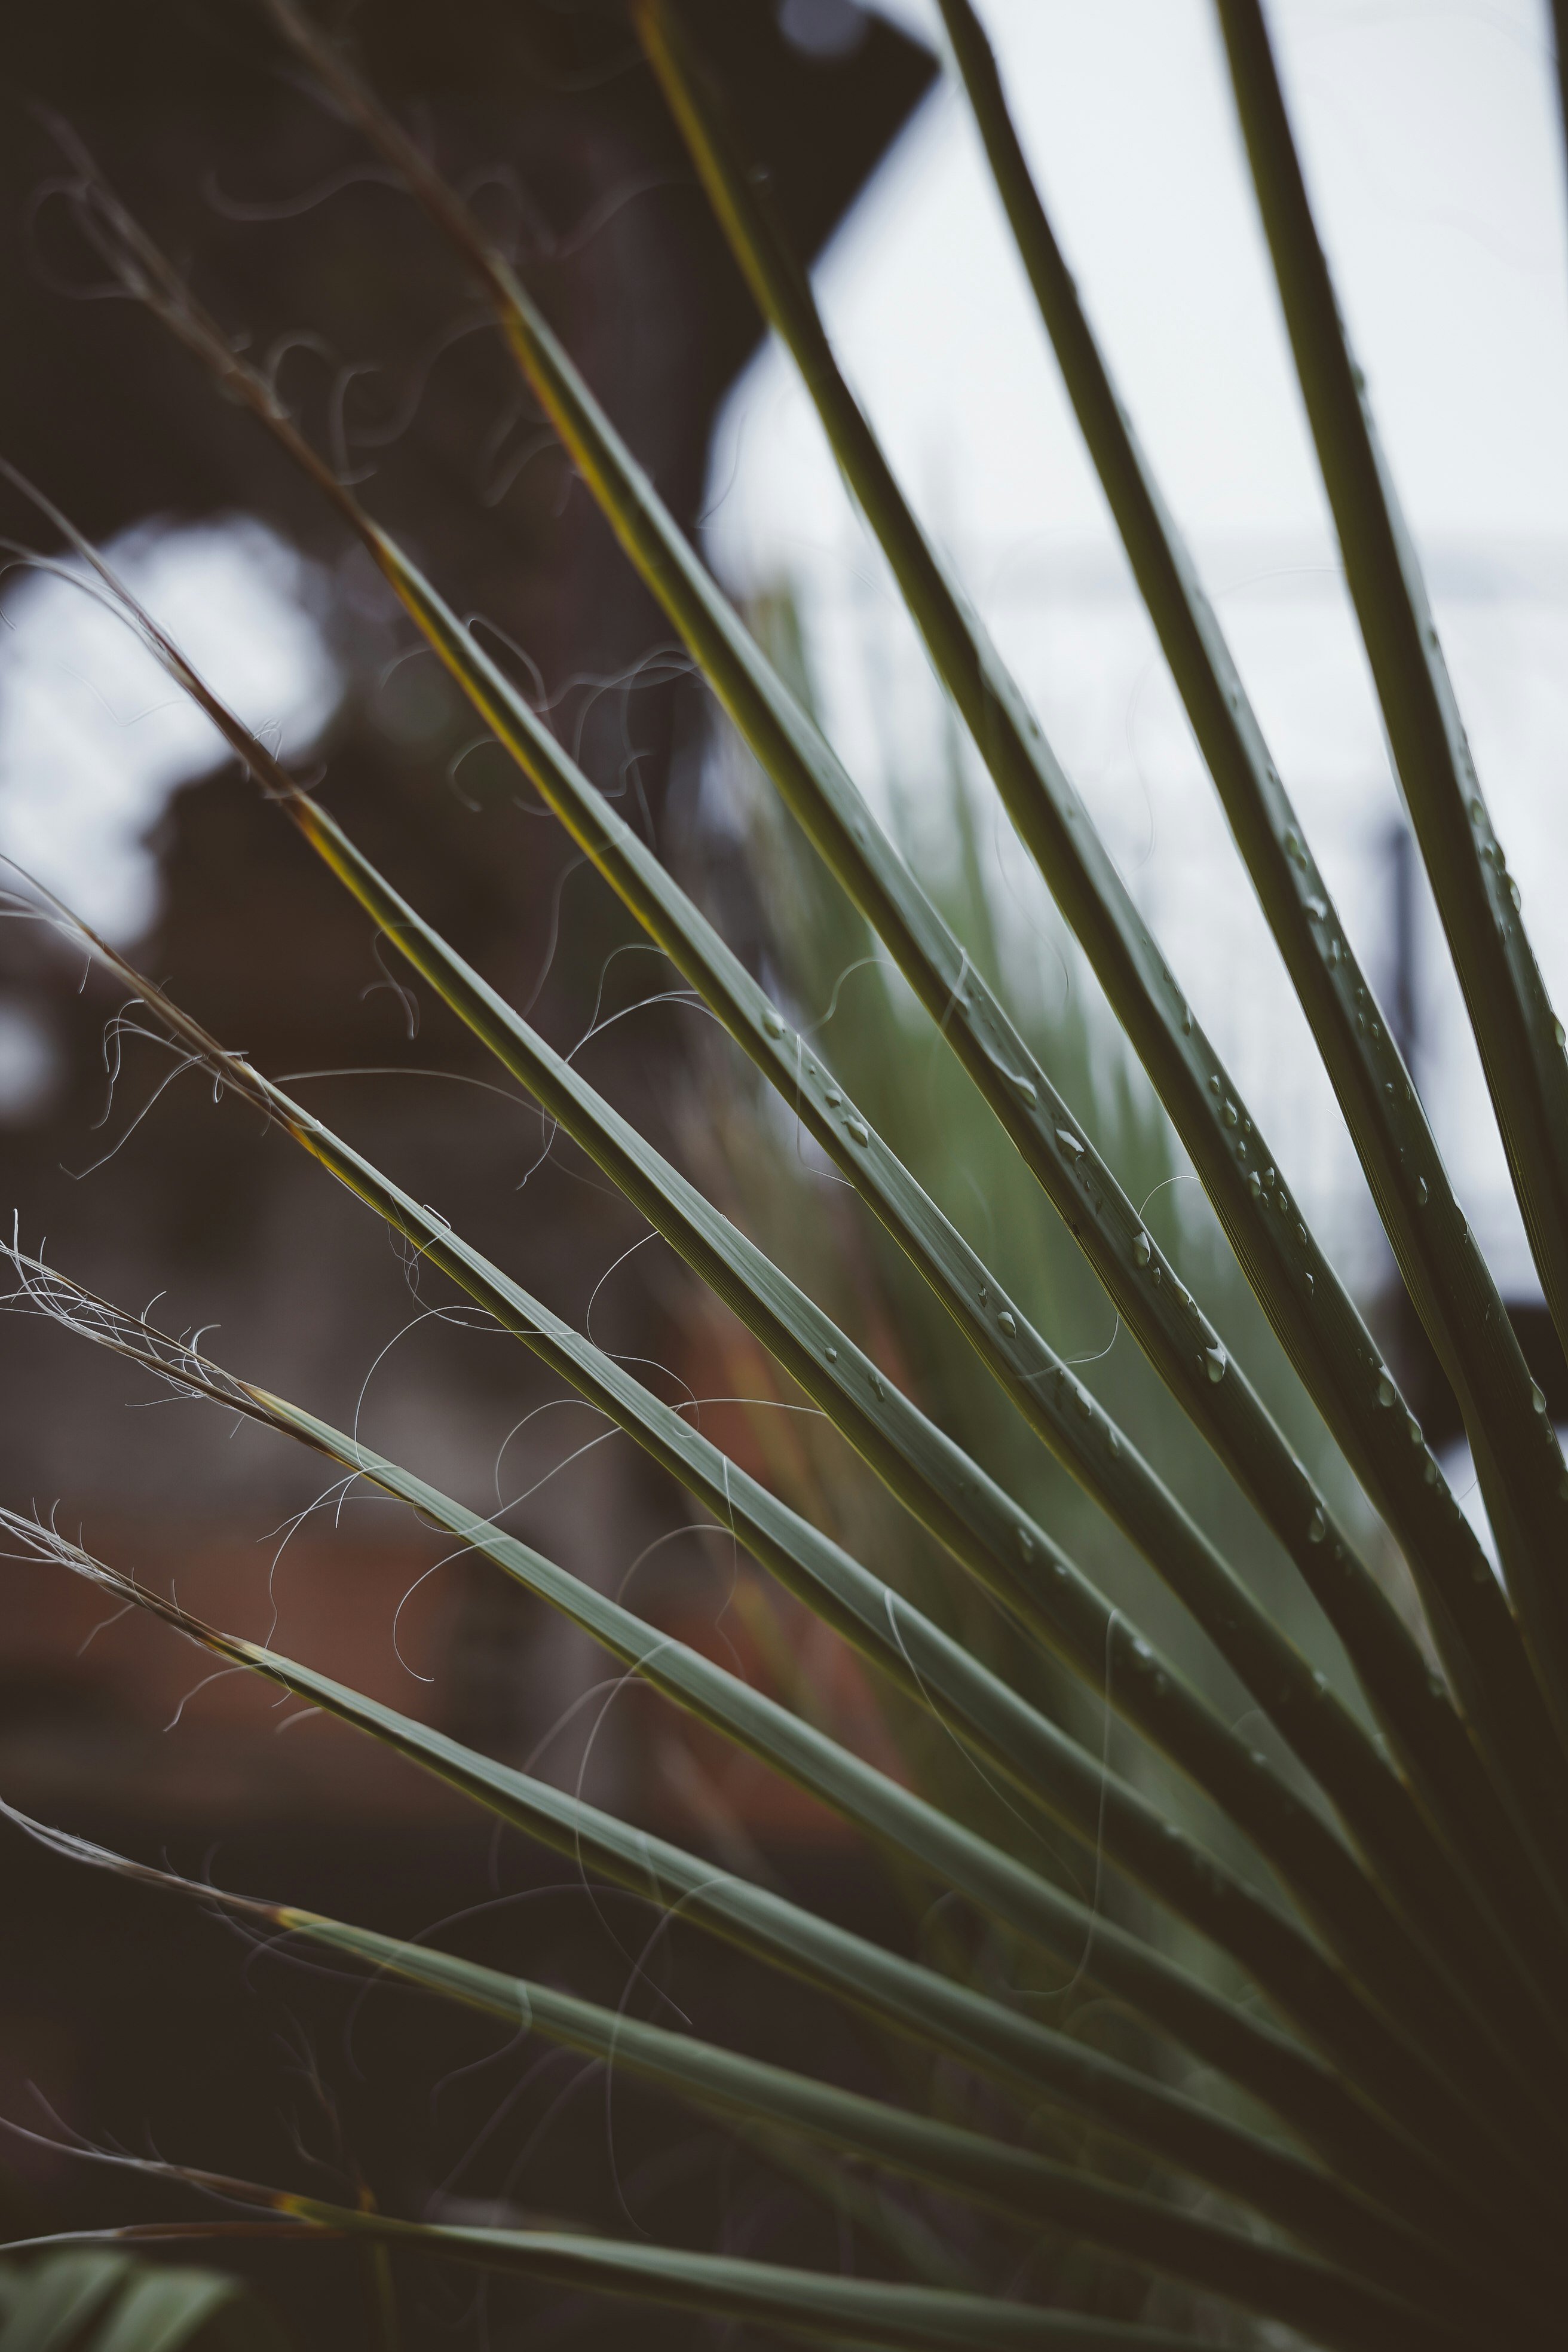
[0,515,341,943]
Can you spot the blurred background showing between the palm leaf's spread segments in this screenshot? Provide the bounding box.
[0,0,1568,2345]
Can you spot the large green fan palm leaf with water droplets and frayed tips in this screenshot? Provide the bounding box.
[12,0,1568,2352]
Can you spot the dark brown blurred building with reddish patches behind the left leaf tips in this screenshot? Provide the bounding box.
[0,0,933,2314]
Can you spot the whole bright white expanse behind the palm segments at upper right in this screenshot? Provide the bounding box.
[708,0,1568,1364]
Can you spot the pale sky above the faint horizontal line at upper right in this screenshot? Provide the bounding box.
[717,0,1568,560]
